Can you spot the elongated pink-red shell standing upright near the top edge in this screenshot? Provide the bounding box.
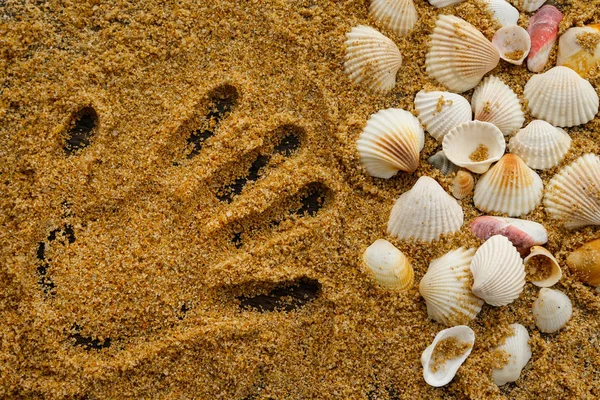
[527,5,563,72]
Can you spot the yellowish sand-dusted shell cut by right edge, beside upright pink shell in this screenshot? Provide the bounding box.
[556,24,600,77]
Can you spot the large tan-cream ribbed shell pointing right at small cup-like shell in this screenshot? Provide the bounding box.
[425,15,500,92]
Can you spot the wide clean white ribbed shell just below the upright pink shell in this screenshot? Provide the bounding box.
[524,67,599,127]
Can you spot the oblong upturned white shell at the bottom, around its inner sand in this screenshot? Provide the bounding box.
[421,325,475,387]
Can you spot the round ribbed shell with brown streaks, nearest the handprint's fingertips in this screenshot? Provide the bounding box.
[356,108,425,179]
